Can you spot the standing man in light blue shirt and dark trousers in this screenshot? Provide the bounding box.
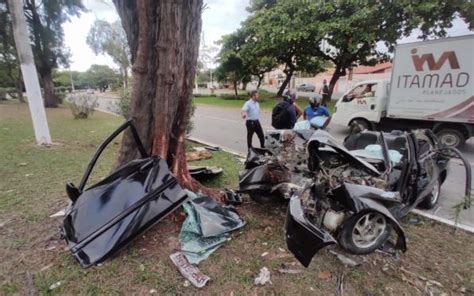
[241,90,265,149]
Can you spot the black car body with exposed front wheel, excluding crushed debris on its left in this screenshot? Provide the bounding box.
[286,130,471,266]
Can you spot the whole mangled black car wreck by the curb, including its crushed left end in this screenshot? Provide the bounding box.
[239,130,471,267]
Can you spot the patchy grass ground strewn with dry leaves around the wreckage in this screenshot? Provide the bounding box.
[0,102,474,295]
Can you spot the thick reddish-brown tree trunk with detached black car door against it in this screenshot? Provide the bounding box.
[113,0,217,197]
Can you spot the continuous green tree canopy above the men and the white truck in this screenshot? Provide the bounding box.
[220,0,473,94]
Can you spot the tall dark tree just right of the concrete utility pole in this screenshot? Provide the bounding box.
[24,0,84,107]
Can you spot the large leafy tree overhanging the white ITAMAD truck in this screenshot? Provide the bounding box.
[308,0,472,99]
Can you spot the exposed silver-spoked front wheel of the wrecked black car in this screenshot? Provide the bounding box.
[338,212,390,255]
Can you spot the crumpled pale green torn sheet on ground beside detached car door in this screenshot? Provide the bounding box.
[179,191,245,264]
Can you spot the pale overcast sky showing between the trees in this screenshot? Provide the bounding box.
[63,0,472,71]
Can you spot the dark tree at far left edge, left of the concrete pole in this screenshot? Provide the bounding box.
[0,0,25,103]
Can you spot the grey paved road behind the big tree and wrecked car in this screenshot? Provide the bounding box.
[191,105,474,229]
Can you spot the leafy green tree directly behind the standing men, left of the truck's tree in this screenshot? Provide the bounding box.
[244,0,323,95]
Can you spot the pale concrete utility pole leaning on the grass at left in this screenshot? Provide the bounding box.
[8,0,51,145]
